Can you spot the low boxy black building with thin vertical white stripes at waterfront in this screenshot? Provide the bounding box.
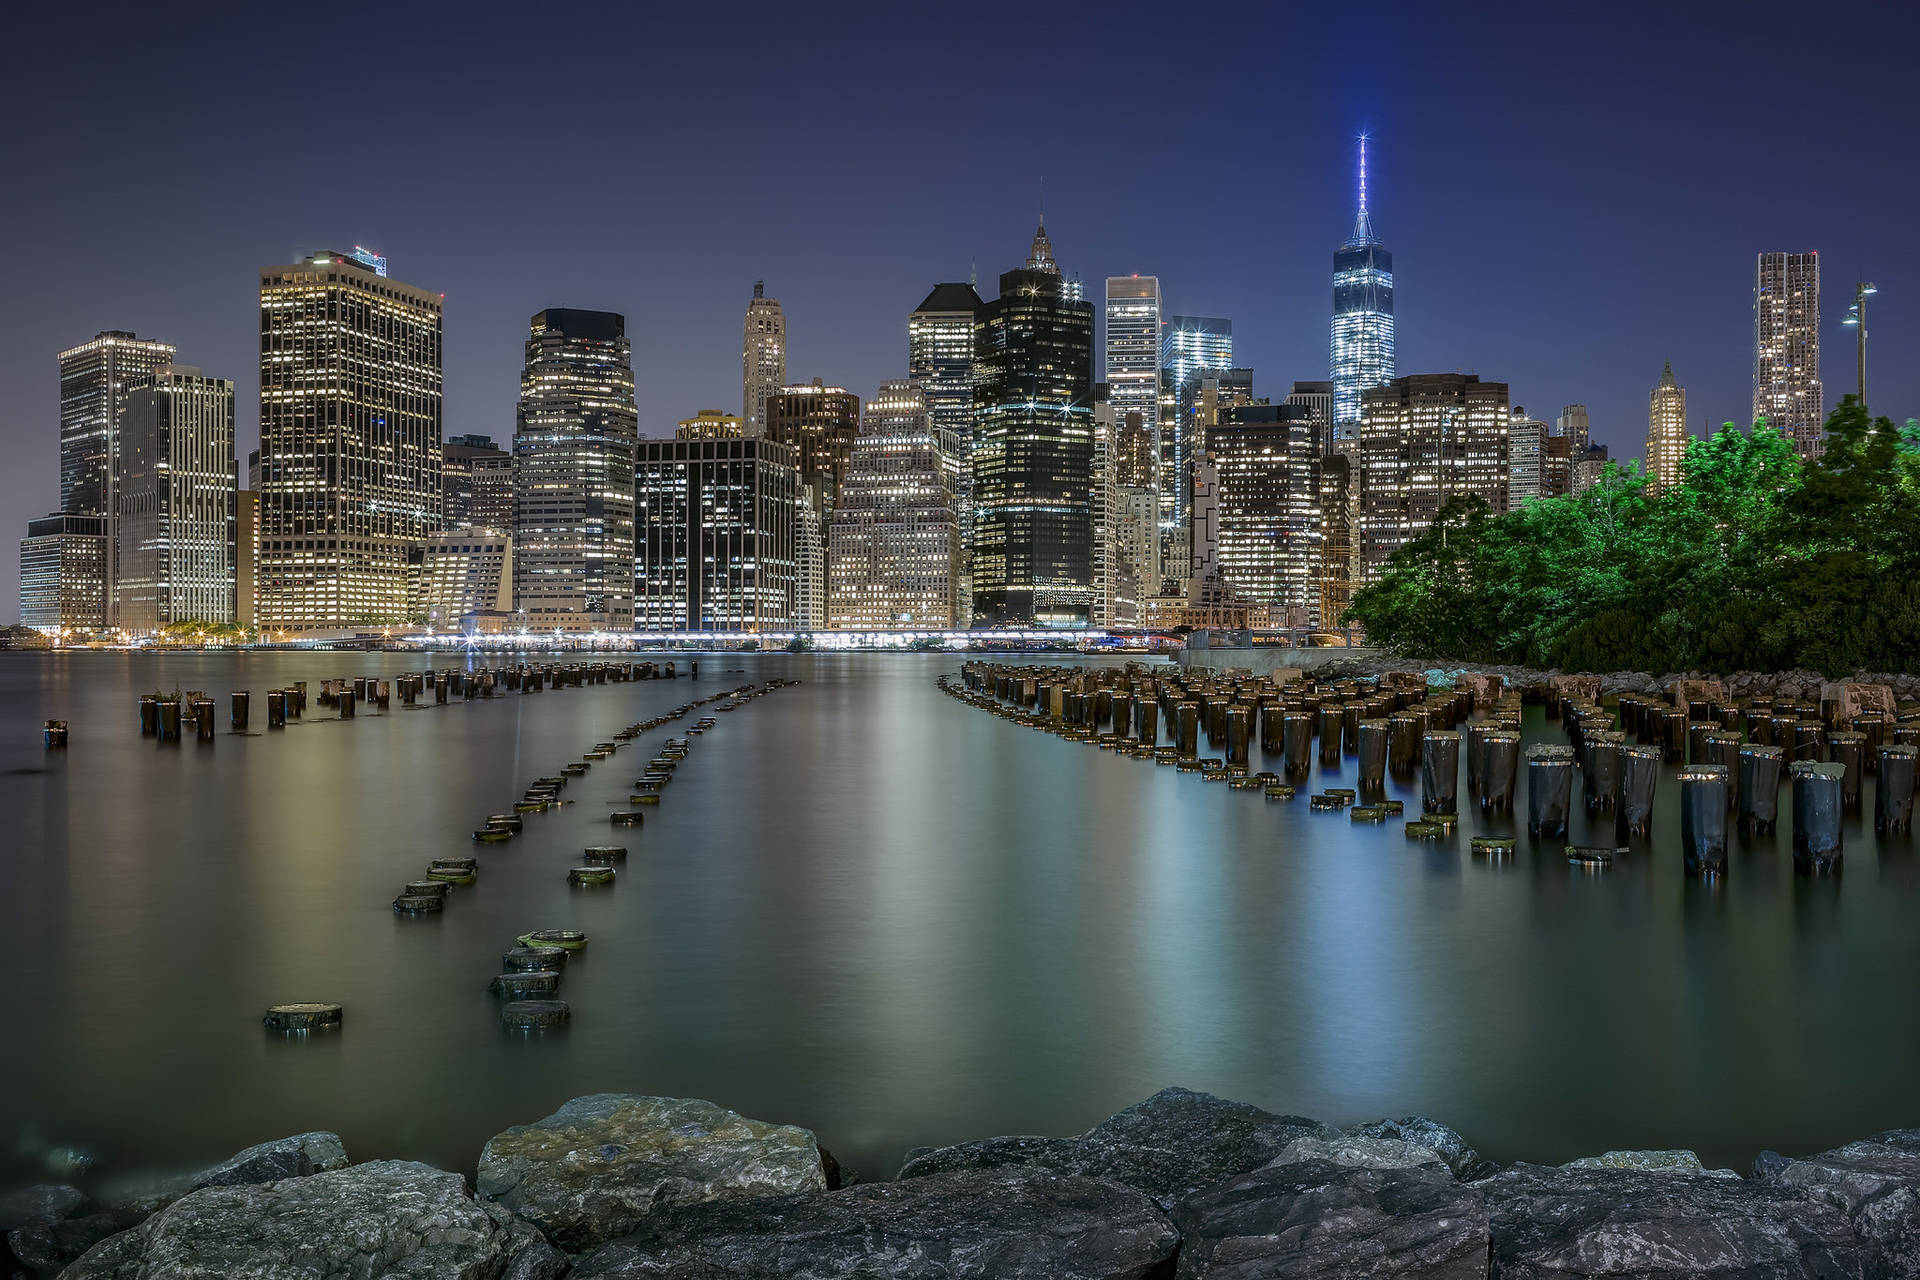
[634,438,801,633]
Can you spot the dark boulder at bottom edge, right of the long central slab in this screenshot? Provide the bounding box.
[1173,1157,1488,1280]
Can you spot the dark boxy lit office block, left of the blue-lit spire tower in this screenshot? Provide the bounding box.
[1206,403,1325,626]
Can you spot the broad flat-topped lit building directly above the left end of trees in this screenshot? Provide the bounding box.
[1359,374,1513,581]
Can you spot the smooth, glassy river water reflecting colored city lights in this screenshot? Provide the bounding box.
[0,652,1920,1184]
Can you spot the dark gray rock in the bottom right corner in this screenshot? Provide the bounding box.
[1753,1128,1920,1276]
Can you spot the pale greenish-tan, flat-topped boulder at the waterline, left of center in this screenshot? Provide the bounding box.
[476,1094,828,1253]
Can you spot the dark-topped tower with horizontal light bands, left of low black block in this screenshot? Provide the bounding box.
[513,307,639,631]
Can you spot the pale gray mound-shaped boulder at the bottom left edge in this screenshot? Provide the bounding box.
[63,1161,509,1280]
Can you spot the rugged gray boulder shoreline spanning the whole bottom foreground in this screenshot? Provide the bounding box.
[0,1088,1920,1280]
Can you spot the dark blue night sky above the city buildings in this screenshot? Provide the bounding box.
[0,0,1920,620]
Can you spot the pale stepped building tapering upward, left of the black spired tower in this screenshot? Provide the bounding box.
[828,380,962,631]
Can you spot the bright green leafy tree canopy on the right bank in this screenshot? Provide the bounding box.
[1344,395,1920,676]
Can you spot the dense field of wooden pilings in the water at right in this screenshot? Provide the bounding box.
[950,662,1920,875]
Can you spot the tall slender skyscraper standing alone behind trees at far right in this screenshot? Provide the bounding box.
[1753,253,1826,459]
